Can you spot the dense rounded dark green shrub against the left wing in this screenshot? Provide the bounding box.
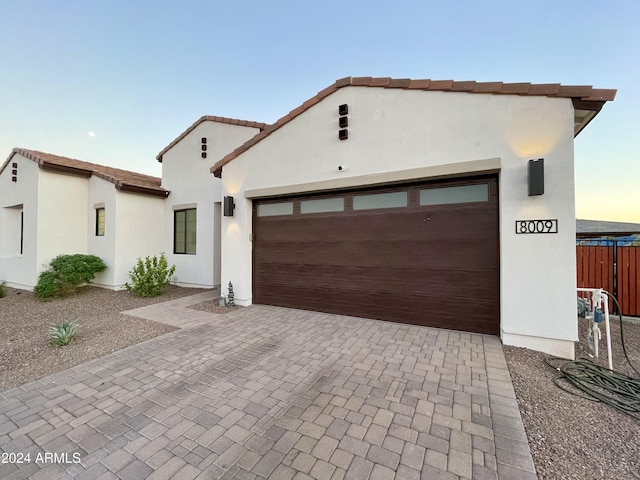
[33,253,107,300]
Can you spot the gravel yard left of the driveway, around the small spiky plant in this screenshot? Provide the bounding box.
[0,286,207,391]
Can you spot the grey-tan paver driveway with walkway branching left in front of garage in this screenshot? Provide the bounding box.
[0,293,536,480]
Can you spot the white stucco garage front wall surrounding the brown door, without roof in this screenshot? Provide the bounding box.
[222,87,577,357]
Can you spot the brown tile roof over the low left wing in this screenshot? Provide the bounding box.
[0,148,169,197]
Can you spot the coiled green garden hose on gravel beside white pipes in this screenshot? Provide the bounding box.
[545,292,640,420]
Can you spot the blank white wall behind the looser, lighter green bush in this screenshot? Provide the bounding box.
[113,191,166,288]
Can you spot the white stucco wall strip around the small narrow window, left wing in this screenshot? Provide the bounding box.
[87,177,121,287]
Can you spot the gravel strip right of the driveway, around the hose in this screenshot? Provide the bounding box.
[504,317,640,480]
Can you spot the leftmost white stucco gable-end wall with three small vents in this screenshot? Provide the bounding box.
[0,154,39,289]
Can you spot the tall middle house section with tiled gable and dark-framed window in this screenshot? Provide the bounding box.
[156,116,266,287]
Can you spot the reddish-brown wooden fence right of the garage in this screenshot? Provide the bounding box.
[576,246,640,317]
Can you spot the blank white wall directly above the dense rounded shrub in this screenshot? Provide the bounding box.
[36,170,89,272]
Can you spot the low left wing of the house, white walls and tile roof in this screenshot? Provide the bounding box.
[0,148,169,289]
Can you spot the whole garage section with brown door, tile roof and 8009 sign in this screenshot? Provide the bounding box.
[211,77,615,358]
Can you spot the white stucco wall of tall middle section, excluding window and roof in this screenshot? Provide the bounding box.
[162,121,259,287]
